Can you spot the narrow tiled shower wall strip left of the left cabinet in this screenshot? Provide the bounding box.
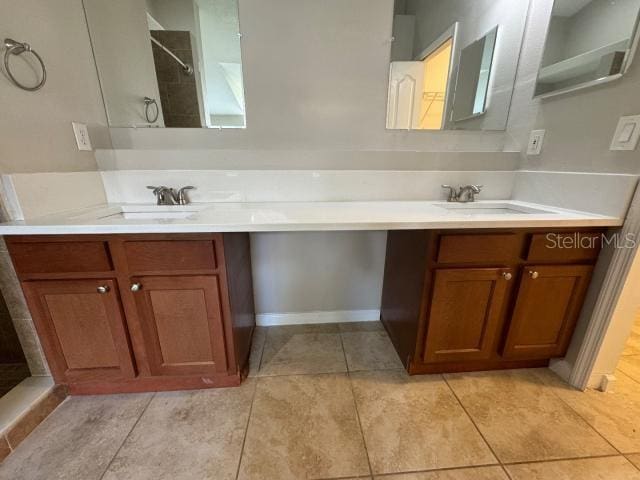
[0,237,50,375]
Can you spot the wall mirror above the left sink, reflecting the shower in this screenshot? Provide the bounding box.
[84,0,245,128]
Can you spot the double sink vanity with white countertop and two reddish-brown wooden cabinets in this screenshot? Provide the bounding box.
[0,184,622,394]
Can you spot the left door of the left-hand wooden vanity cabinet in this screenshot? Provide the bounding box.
[23,279,135,383]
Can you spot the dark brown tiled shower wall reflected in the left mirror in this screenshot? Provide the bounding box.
[151,30,202,127]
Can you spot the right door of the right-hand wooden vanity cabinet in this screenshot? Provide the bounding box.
[503,265,593,359]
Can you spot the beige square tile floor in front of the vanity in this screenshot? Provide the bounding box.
[0,323,640,480]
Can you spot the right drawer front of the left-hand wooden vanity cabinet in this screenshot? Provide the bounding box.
[124,239,217,273]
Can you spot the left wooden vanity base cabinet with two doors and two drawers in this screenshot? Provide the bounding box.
[6,233,255,394]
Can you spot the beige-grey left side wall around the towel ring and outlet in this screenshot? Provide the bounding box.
[0,0,110,173]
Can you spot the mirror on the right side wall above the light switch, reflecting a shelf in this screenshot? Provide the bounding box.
[535,0,640,97]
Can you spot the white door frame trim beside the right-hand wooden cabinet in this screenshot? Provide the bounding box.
[550,188,640,390]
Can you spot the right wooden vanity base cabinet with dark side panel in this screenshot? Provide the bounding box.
[381,229,603,374]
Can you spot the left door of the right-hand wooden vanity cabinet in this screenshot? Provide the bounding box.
[424,268,512,363]
